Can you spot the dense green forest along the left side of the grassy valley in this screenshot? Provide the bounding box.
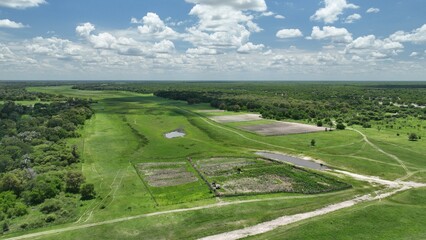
[0,84,94,232]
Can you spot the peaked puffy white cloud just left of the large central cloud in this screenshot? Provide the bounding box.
[137,12,178,39]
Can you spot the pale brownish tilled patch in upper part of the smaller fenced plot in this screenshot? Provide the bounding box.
[138,162,198,187]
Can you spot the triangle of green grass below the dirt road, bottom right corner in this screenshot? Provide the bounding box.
[247,188,426,240]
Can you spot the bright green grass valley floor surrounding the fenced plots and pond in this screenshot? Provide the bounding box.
[4,86,426,239]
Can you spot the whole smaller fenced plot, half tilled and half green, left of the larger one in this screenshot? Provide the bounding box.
[136,162,212,205]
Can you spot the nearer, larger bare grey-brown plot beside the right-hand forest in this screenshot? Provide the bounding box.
[240,122,325,136]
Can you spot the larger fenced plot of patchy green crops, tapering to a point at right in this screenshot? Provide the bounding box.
[196,158,350,196]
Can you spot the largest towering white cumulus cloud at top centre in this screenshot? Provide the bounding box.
[184,0,268,51]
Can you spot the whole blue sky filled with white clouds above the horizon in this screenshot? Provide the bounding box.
[0,0,426,81]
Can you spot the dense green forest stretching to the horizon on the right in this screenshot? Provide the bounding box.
[74,82,426,127]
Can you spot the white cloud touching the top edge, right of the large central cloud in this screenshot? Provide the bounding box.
[311,0,359,23]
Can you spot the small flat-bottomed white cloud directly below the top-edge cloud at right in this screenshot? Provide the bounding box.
[308,26,352,43]
